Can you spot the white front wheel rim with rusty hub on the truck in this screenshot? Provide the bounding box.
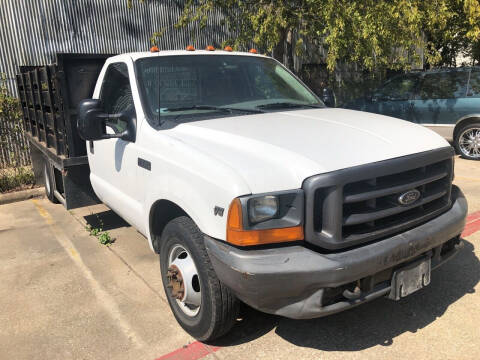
[167,245,202,317]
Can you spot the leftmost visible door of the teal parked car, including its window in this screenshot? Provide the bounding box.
[368,74,418,121]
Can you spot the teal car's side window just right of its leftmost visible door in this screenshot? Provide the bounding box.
[419,71,468,100]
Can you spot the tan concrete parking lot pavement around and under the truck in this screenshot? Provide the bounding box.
[0,158,480,360]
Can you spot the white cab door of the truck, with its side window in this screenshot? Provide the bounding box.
[87,62,142,226]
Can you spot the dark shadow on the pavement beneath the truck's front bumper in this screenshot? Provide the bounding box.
[215,240,480,351]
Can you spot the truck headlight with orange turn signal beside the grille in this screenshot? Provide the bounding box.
[227,190,304,246]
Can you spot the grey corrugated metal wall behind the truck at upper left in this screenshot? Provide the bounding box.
[0,0,231,167]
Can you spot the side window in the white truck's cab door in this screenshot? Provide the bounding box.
[100,63,135,132]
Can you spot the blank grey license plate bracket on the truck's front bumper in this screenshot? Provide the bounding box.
[388,258,431,300]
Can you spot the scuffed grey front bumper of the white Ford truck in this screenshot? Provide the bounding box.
[205,186,468,319]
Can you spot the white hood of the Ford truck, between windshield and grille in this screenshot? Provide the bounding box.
[167,108,449,193]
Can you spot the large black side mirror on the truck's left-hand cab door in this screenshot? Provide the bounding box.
[77,99,135,141]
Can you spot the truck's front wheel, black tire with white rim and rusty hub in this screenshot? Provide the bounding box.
[160,216,239,341]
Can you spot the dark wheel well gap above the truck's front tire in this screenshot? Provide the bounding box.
[149,200,188,254]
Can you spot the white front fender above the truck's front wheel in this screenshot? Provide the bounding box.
[139,134,251,249]
